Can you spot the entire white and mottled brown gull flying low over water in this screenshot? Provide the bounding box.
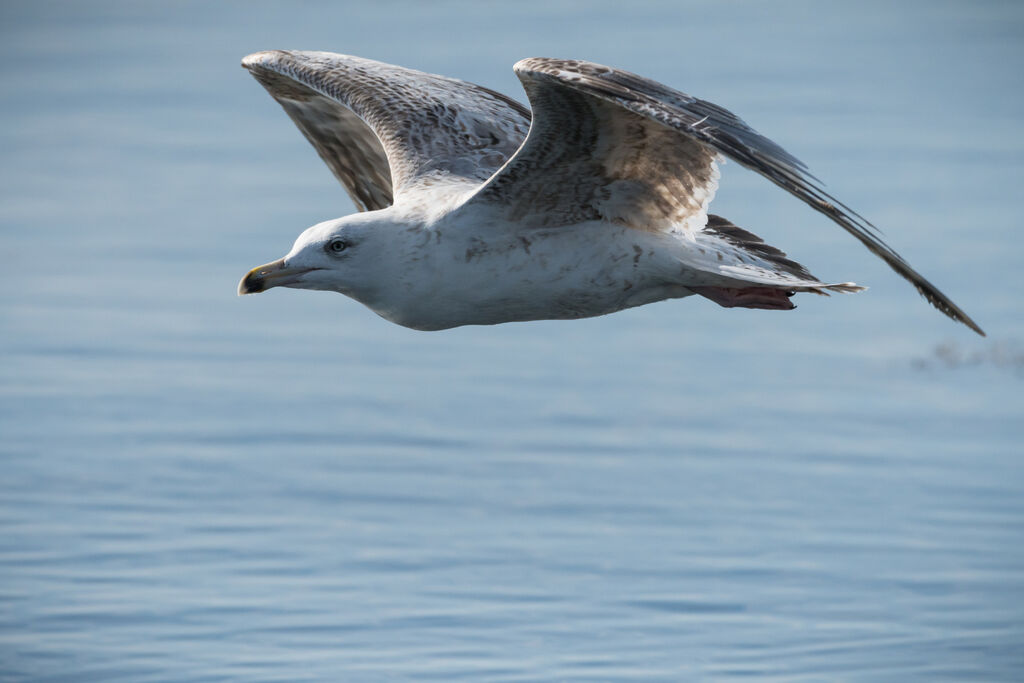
[239,50,984,335]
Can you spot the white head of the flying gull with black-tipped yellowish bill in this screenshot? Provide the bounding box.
[239,214,389,300]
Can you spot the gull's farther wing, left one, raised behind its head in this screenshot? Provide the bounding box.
[242,50,529,210]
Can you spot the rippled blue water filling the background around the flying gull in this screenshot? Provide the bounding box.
[0,1,1024,681]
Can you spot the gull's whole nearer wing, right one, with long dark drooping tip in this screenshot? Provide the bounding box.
[470,57,984,335]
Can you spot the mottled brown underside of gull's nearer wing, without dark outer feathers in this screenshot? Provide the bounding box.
[474,58,718,230]
